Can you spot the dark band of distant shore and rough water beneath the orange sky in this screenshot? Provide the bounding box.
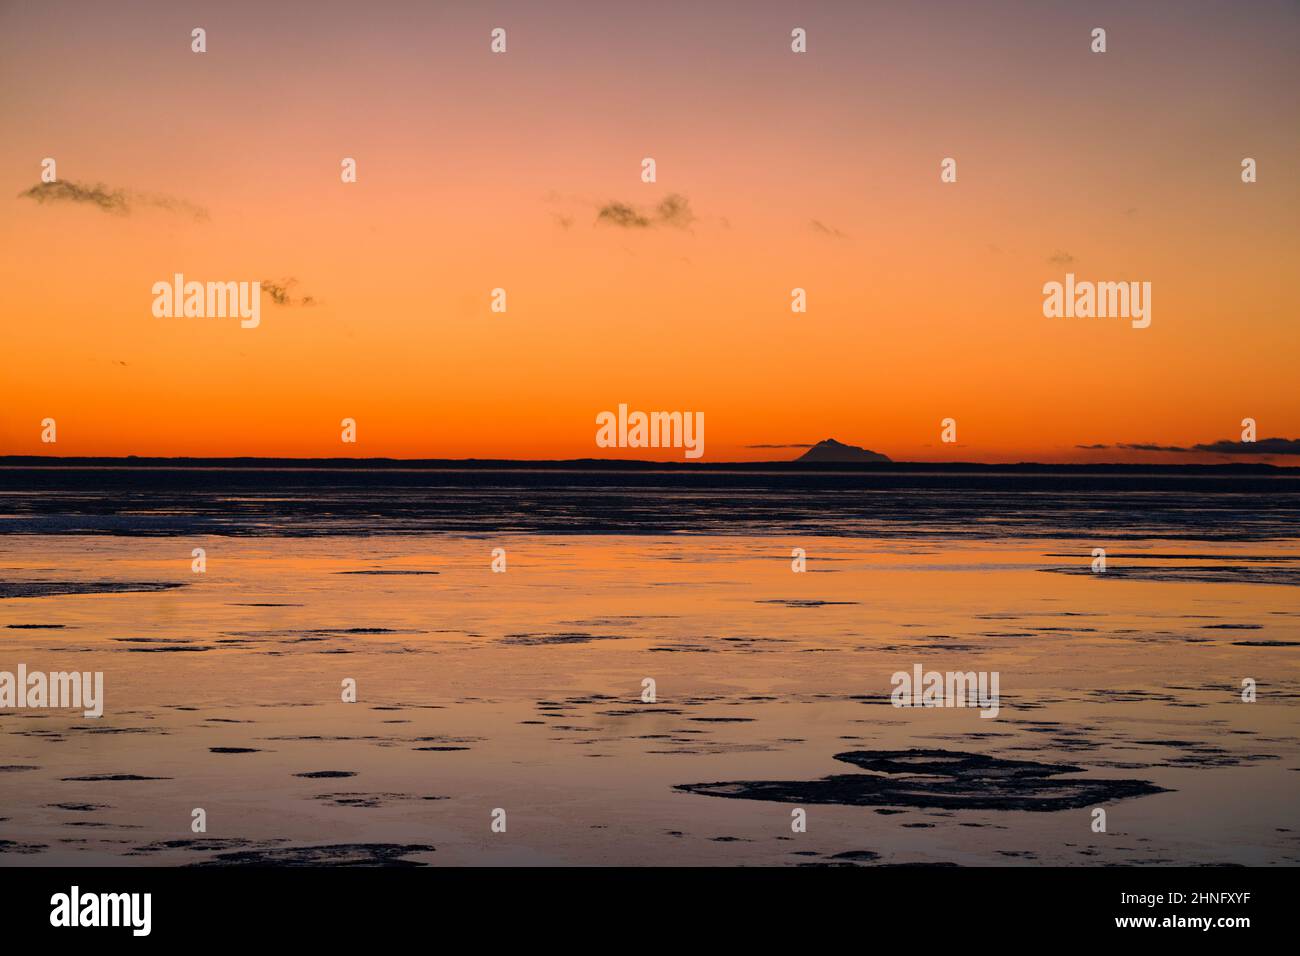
[0,458,1300,541]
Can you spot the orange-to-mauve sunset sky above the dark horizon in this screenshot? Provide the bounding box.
[0,0,1300,463]
